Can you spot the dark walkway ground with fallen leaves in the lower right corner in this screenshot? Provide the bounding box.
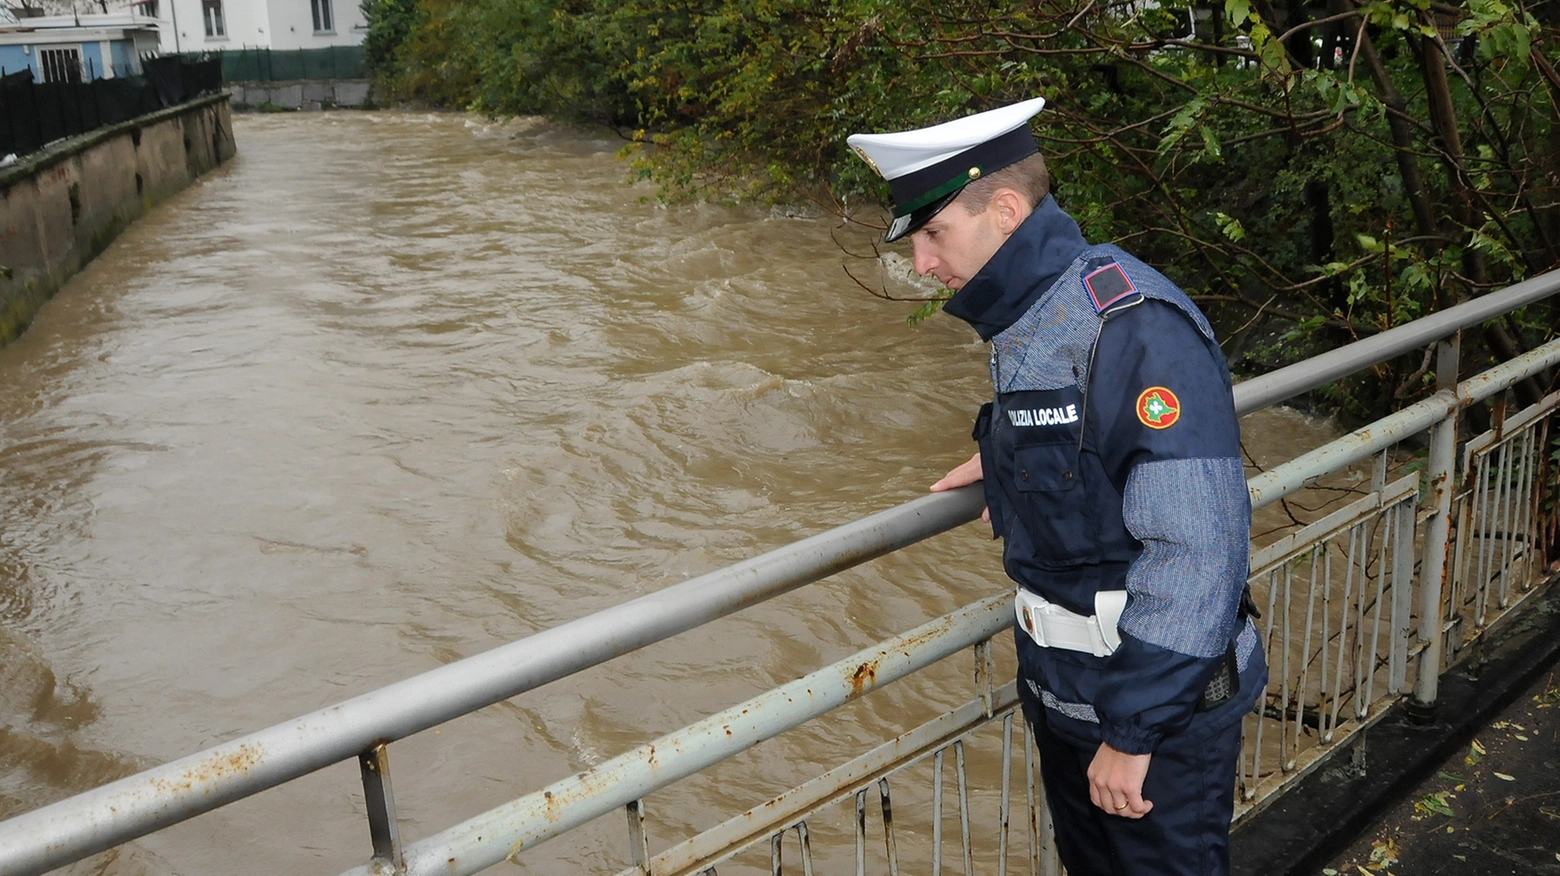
[1231,585,1560,876]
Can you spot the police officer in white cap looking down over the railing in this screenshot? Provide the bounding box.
[849,98,1267,876]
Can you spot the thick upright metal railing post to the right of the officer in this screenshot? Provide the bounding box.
[1413,332,1462,711]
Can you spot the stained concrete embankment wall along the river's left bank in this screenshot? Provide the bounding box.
[0,94,237,344]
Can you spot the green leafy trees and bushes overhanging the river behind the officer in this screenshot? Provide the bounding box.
[365,0,1560,416]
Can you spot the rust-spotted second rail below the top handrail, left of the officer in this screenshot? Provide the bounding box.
[342,592,1012,876]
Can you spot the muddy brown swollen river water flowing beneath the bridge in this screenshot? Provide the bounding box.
[0,112,1324,874]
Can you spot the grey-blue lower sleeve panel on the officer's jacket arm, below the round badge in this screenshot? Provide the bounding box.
[1120,458,1251,658]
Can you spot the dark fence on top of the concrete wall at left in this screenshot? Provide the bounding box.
[0,58,222,156]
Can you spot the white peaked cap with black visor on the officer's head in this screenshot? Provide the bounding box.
[846,97,1045,242]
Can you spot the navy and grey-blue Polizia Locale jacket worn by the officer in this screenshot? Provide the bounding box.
[945,198,1267,754]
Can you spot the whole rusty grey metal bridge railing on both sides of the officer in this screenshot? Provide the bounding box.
[0,274,1560,874]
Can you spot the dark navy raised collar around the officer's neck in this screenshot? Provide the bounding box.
[942,195,1089,341]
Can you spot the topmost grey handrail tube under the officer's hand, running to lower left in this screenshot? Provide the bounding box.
[0,486,984,876]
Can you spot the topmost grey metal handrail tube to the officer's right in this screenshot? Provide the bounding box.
[1236,271,1560,416]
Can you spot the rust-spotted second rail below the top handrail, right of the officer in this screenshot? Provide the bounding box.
[1246,338,1560,510]
